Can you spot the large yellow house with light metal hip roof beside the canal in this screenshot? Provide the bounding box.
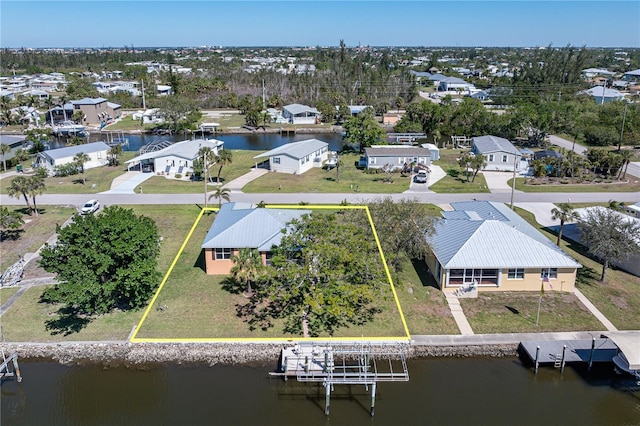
[426,201,582,292]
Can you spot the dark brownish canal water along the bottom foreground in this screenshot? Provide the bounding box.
[0,358,640,426]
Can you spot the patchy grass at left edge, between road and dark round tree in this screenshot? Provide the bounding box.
[0,206,76,270]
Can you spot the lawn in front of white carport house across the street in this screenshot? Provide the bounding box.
[140,149,264,194]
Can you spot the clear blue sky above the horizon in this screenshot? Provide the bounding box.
[0,0,640,48]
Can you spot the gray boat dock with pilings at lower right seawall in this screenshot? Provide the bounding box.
[518,338,618,373]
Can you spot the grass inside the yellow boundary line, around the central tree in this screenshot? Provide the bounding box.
[137,208,404,339]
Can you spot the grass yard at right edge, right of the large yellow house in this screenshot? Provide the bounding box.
[516,207,640,330]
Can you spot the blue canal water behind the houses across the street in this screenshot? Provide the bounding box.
[50,132,342,155]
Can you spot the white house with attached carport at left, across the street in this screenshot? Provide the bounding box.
[126,139,224,176]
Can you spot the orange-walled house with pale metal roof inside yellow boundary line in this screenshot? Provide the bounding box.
[202,203,311,275]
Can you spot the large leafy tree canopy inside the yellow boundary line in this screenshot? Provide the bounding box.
[239,212,388,337]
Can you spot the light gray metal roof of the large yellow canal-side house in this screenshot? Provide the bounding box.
[429,201,581,269]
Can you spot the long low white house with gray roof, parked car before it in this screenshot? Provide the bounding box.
[364,145,431,169]
